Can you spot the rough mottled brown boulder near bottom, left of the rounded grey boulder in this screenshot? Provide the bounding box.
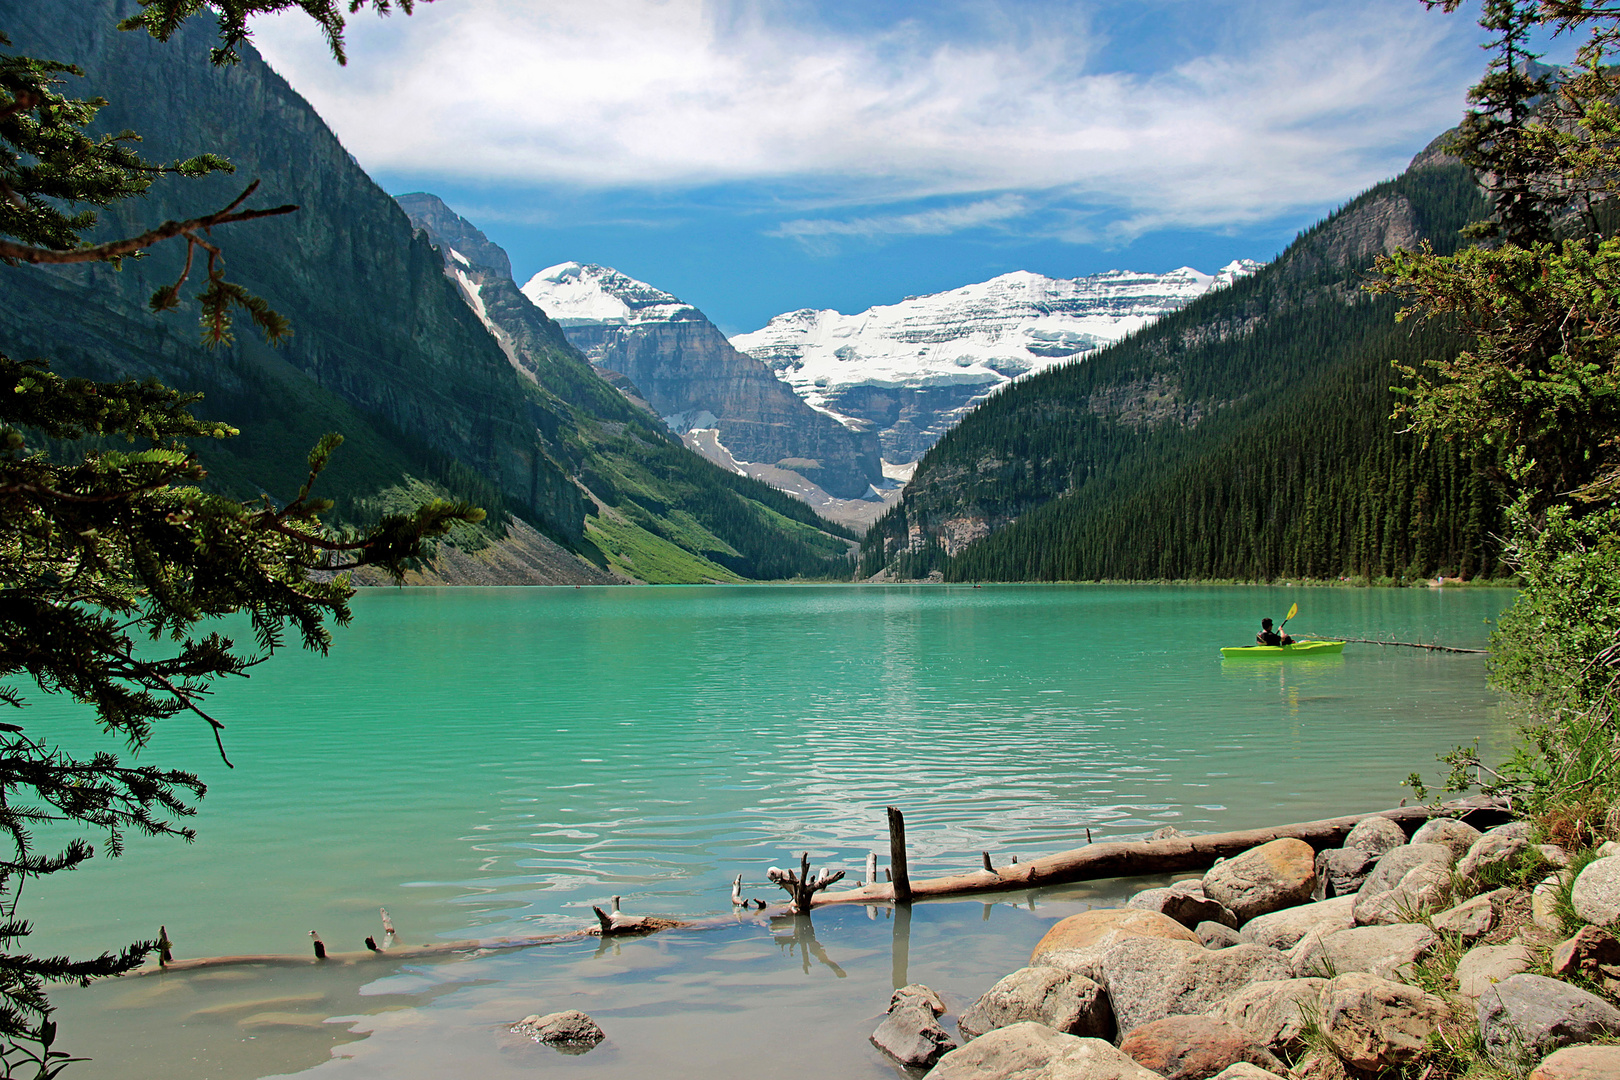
[1319,971,1447,1072]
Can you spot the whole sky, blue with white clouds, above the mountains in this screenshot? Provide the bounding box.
[256,0,1568,334]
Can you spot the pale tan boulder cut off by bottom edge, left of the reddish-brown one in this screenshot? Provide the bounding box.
[928,1020,1163,1080]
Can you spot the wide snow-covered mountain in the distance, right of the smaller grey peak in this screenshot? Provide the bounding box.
[729,259,1260,465]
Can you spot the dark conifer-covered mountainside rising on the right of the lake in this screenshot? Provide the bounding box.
[860,151,1499,581]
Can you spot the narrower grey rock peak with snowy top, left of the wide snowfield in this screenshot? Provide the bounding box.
[523,262,885,505]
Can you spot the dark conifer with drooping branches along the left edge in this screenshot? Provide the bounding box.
[0,0,469,1078]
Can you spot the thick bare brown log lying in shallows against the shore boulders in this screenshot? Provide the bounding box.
[813,800,1510,907]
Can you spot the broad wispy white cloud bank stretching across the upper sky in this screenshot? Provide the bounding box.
[256,0,1481,241]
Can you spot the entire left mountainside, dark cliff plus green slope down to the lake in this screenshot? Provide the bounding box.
[0,0,849,583]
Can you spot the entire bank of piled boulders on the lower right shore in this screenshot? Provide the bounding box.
[872,818,1620,1080]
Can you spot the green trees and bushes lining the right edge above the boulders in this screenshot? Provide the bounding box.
[1375,0,1620,850]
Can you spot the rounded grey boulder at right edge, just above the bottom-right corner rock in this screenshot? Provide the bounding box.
[1476,973,1620,1064]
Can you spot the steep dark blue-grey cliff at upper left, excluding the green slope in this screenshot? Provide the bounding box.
[0,0,585,538]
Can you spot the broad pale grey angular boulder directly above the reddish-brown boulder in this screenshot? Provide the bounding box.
[1098,938,1291,1031]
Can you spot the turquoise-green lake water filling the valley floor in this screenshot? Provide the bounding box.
[24,586,1511,1080]
